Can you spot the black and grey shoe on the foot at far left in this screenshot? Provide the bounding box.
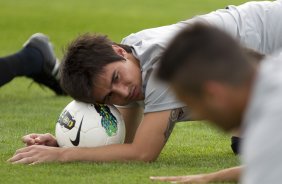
[24,33,66,95]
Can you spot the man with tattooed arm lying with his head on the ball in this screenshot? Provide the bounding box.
[7,1,282,164]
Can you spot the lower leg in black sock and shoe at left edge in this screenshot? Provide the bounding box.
[0,33,65,95]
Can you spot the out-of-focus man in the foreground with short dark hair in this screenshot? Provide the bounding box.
[151,24,282,184]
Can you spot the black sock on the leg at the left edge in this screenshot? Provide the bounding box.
[0,47,43,86]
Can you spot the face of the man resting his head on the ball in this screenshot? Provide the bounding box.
[94,59,144,105]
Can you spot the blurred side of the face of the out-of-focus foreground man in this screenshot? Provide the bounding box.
[174,82,242,131]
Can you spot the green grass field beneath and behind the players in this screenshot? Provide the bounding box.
[0,0,246,184]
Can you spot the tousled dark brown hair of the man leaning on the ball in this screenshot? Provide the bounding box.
[60,33,131,103]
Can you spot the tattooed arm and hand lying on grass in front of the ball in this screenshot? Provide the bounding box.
[9,106,188,164]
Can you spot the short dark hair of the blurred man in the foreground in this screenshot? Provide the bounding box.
[158,23,263,95]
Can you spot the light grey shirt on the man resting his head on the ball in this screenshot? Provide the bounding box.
[121,0,282,113]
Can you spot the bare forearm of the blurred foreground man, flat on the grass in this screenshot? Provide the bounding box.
[150,166,243,183]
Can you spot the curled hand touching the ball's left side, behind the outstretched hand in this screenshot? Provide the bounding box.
[22,133,58,147]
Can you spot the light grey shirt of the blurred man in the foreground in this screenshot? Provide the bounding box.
[242,52,282,184]
